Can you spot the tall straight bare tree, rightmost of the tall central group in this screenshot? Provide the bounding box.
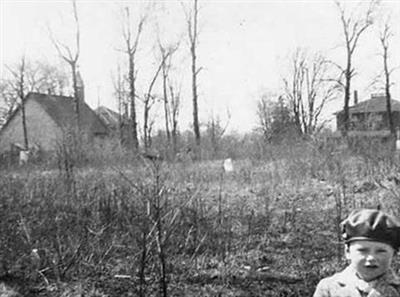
[186,0,201,157]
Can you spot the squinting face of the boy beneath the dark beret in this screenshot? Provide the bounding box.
[346,240,395,281]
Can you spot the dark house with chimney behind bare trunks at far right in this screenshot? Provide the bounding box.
[336,94,400,138]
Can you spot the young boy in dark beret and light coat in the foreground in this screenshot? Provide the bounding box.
[314,209,400,297]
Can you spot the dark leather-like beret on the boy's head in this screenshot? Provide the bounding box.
[341,209,400,250]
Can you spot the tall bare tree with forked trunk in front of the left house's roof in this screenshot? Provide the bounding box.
[49,0,82,131]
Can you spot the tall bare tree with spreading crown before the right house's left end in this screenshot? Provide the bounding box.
[335,0,379,136]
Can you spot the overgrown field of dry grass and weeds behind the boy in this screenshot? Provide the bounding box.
[0,139,400,296]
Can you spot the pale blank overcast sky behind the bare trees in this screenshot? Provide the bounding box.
[0,0,400,132]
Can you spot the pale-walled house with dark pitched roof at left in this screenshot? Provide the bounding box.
[0,93,108,153]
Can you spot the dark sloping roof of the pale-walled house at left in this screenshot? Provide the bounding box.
[2,93,108,134]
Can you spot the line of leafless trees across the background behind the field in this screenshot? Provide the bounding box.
[0,0,395,158]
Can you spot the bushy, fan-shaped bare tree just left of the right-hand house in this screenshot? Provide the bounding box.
[284,48,337,135]
